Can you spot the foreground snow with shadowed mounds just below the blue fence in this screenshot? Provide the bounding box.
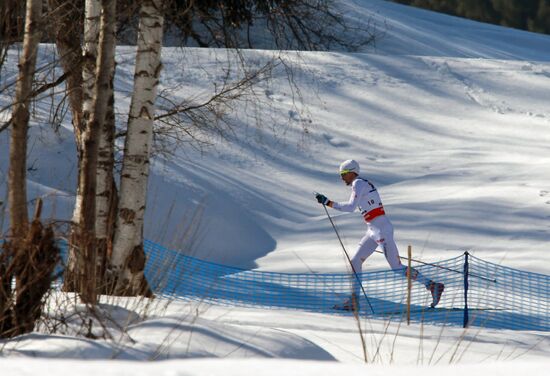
[1,298,550,364]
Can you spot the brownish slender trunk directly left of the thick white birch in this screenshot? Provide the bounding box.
[77,0,116,304]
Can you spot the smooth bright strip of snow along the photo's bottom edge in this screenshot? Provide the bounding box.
[2,359,548,376]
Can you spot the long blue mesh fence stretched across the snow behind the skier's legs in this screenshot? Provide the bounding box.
[145,241,550,331]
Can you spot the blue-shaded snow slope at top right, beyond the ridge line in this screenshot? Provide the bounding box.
[342,0,550,61]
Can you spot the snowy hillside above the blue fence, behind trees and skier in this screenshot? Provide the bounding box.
[0,1,550,273]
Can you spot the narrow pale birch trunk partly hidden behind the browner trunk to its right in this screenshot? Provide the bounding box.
[64,0,101,291]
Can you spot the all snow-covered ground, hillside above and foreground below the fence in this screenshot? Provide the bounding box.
[0,0,550,375]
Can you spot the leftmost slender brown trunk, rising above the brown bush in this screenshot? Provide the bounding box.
[8,0,42,249]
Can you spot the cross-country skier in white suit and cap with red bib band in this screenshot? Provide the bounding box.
[315,159,445,311]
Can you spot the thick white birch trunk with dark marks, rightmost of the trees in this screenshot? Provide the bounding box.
[111,0,164,296]
